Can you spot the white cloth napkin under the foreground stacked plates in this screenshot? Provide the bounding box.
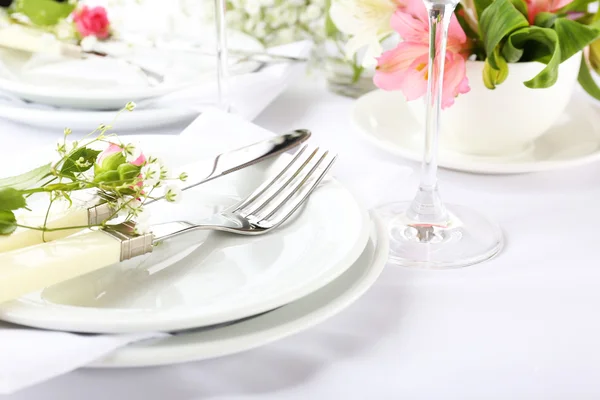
[0,109,411,394]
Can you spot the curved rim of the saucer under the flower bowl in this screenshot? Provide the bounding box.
[351,89,600,175]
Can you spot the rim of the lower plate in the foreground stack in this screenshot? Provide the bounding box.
[89,212,389,369]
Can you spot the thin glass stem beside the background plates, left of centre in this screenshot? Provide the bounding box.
[215,0,230,111]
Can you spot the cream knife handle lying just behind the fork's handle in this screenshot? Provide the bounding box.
[0,208,89,252]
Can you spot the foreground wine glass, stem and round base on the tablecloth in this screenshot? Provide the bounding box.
[379,0,504,269]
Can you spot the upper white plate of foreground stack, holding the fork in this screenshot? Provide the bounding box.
[0,136,370,333]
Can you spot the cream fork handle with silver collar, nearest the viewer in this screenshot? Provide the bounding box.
[0,230,152,303]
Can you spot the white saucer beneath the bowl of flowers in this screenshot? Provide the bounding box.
[352,90,600,174]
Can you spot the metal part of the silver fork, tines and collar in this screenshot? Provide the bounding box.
[105,145,336,261]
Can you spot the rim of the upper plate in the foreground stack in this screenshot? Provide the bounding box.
[0,139,371,333]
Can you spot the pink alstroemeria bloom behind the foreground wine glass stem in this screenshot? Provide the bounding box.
[374,0,470,108]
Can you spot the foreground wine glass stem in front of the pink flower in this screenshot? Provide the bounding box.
[407,0,456,225]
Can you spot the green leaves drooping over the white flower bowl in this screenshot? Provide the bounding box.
[474,0,600,89]
